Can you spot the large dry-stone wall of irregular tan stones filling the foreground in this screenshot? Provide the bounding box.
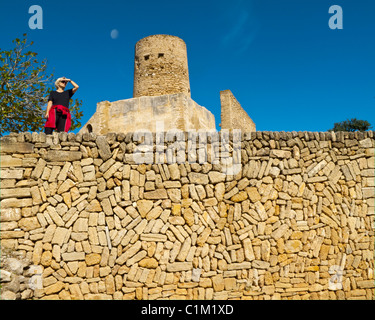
[0,131,375,300]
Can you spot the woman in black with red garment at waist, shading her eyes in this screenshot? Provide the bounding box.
[44,77,79,134]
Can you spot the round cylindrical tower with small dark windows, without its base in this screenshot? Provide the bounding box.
[133,34,191,98]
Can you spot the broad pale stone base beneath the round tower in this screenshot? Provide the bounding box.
[80,93,216,135]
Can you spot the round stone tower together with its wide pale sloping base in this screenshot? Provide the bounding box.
[80,34,217,135]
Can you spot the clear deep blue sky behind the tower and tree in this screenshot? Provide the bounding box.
[0,0,375,131]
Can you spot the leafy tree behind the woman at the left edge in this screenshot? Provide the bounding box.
[0,34,83,136]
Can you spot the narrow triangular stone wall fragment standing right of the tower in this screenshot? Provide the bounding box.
[220,90,256,132]
